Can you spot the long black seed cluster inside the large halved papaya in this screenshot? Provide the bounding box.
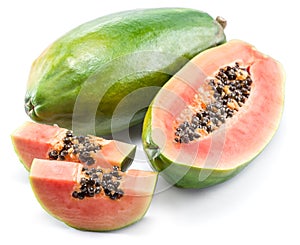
[174,62,252,143]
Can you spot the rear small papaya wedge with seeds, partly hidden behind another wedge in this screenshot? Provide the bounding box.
[11,122,136,170]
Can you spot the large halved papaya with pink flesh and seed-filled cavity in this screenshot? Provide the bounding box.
[143,40,285,188]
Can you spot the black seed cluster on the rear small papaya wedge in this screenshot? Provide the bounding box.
[48,130,101,166]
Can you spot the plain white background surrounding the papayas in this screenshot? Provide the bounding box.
[0,0,300,245]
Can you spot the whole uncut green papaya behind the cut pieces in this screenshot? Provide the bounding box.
[25,8,225,135]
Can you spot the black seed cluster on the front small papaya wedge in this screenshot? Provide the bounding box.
[72,166,124,200]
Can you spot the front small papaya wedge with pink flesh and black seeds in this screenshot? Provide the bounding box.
[30,159,157,231]
